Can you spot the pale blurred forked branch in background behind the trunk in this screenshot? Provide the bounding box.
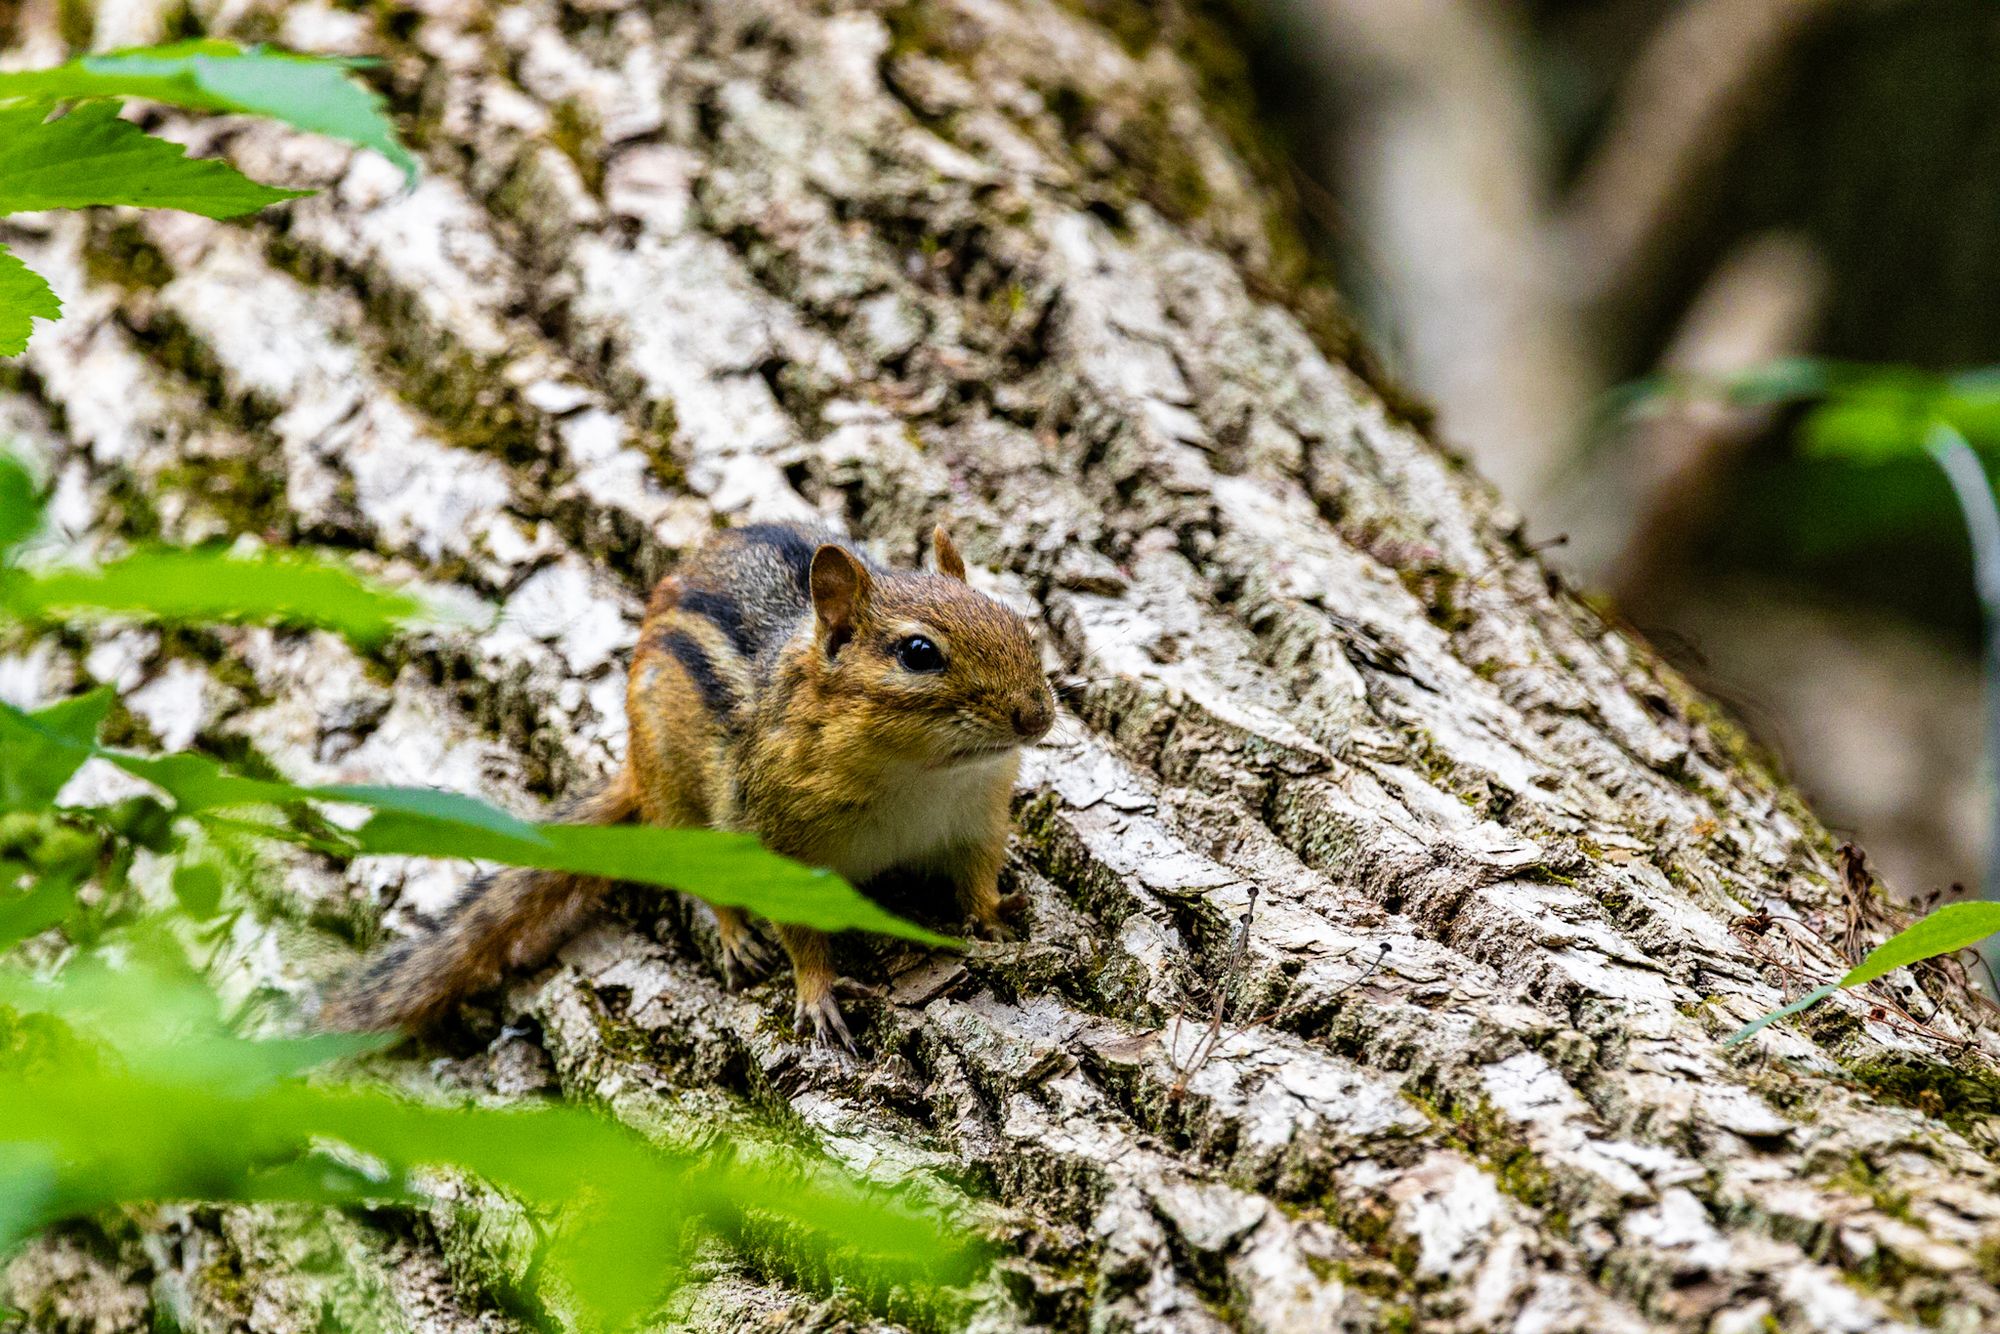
[1290,0,1844,572]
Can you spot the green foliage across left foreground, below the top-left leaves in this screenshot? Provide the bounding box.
[0,454,986,1328]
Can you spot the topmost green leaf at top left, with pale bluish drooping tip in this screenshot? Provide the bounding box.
[0,40,416,182]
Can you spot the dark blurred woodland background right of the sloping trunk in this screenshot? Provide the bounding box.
[1252,0,2000,898]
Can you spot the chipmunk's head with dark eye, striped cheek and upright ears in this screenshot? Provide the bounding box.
[810,528,1056,768]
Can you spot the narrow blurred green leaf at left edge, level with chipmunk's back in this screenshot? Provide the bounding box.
[0,548,424,646]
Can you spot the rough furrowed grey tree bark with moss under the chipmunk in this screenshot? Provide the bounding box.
[0,0,2000,1334]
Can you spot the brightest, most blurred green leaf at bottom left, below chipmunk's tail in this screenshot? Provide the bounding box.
[0,956,986,1328]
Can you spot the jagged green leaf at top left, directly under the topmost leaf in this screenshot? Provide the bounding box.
[0,102,310,218]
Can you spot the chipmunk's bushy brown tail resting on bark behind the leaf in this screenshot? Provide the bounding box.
[320,774,638,1032]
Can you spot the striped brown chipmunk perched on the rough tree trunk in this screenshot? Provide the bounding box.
[322,524,1056,1050]
